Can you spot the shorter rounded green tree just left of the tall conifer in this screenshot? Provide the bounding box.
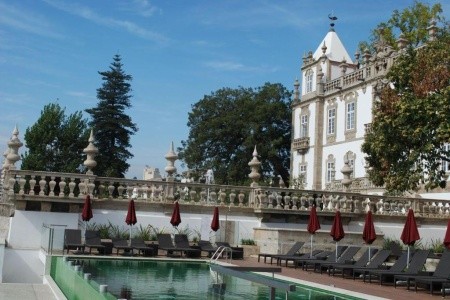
[21,103,89,173]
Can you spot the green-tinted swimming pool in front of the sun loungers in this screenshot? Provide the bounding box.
[50,257,366,300]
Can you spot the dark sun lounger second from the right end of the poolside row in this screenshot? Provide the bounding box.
[363,250,430,285]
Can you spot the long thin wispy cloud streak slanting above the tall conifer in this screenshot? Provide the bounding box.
[44,0,168,44]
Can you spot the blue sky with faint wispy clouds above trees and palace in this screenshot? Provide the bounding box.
[0,0,449,178]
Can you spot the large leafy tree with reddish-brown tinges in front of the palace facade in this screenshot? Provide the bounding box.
[362,27,450,192]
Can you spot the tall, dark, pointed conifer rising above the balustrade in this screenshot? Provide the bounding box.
[86,54,138,177]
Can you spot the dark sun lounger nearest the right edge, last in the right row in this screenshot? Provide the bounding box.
[394,251,450,297]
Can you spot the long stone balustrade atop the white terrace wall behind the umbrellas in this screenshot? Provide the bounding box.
[2,170,450,218]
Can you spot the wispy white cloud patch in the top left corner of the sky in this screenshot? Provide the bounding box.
[0,2,64,39]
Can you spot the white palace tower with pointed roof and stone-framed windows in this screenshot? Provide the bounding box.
[291,24,393,190]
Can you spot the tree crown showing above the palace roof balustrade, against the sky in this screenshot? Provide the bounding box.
[359,1,444,53]
